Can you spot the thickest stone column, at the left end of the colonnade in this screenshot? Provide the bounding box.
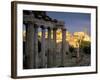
[25,23,35,69]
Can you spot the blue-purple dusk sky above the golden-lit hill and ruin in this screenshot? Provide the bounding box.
[47,12,91,35]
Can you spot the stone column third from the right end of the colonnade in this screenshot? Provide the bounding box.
[47,28,52,68]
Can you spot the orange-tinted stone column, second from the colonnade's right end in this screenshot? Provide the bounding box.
[53,28,57,67]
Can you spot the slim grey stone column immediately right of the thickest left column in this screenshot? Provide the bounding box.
[34,24,39,68]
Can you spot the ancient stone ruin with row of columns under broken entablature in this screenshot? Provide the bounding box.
[23,10,66,69]
